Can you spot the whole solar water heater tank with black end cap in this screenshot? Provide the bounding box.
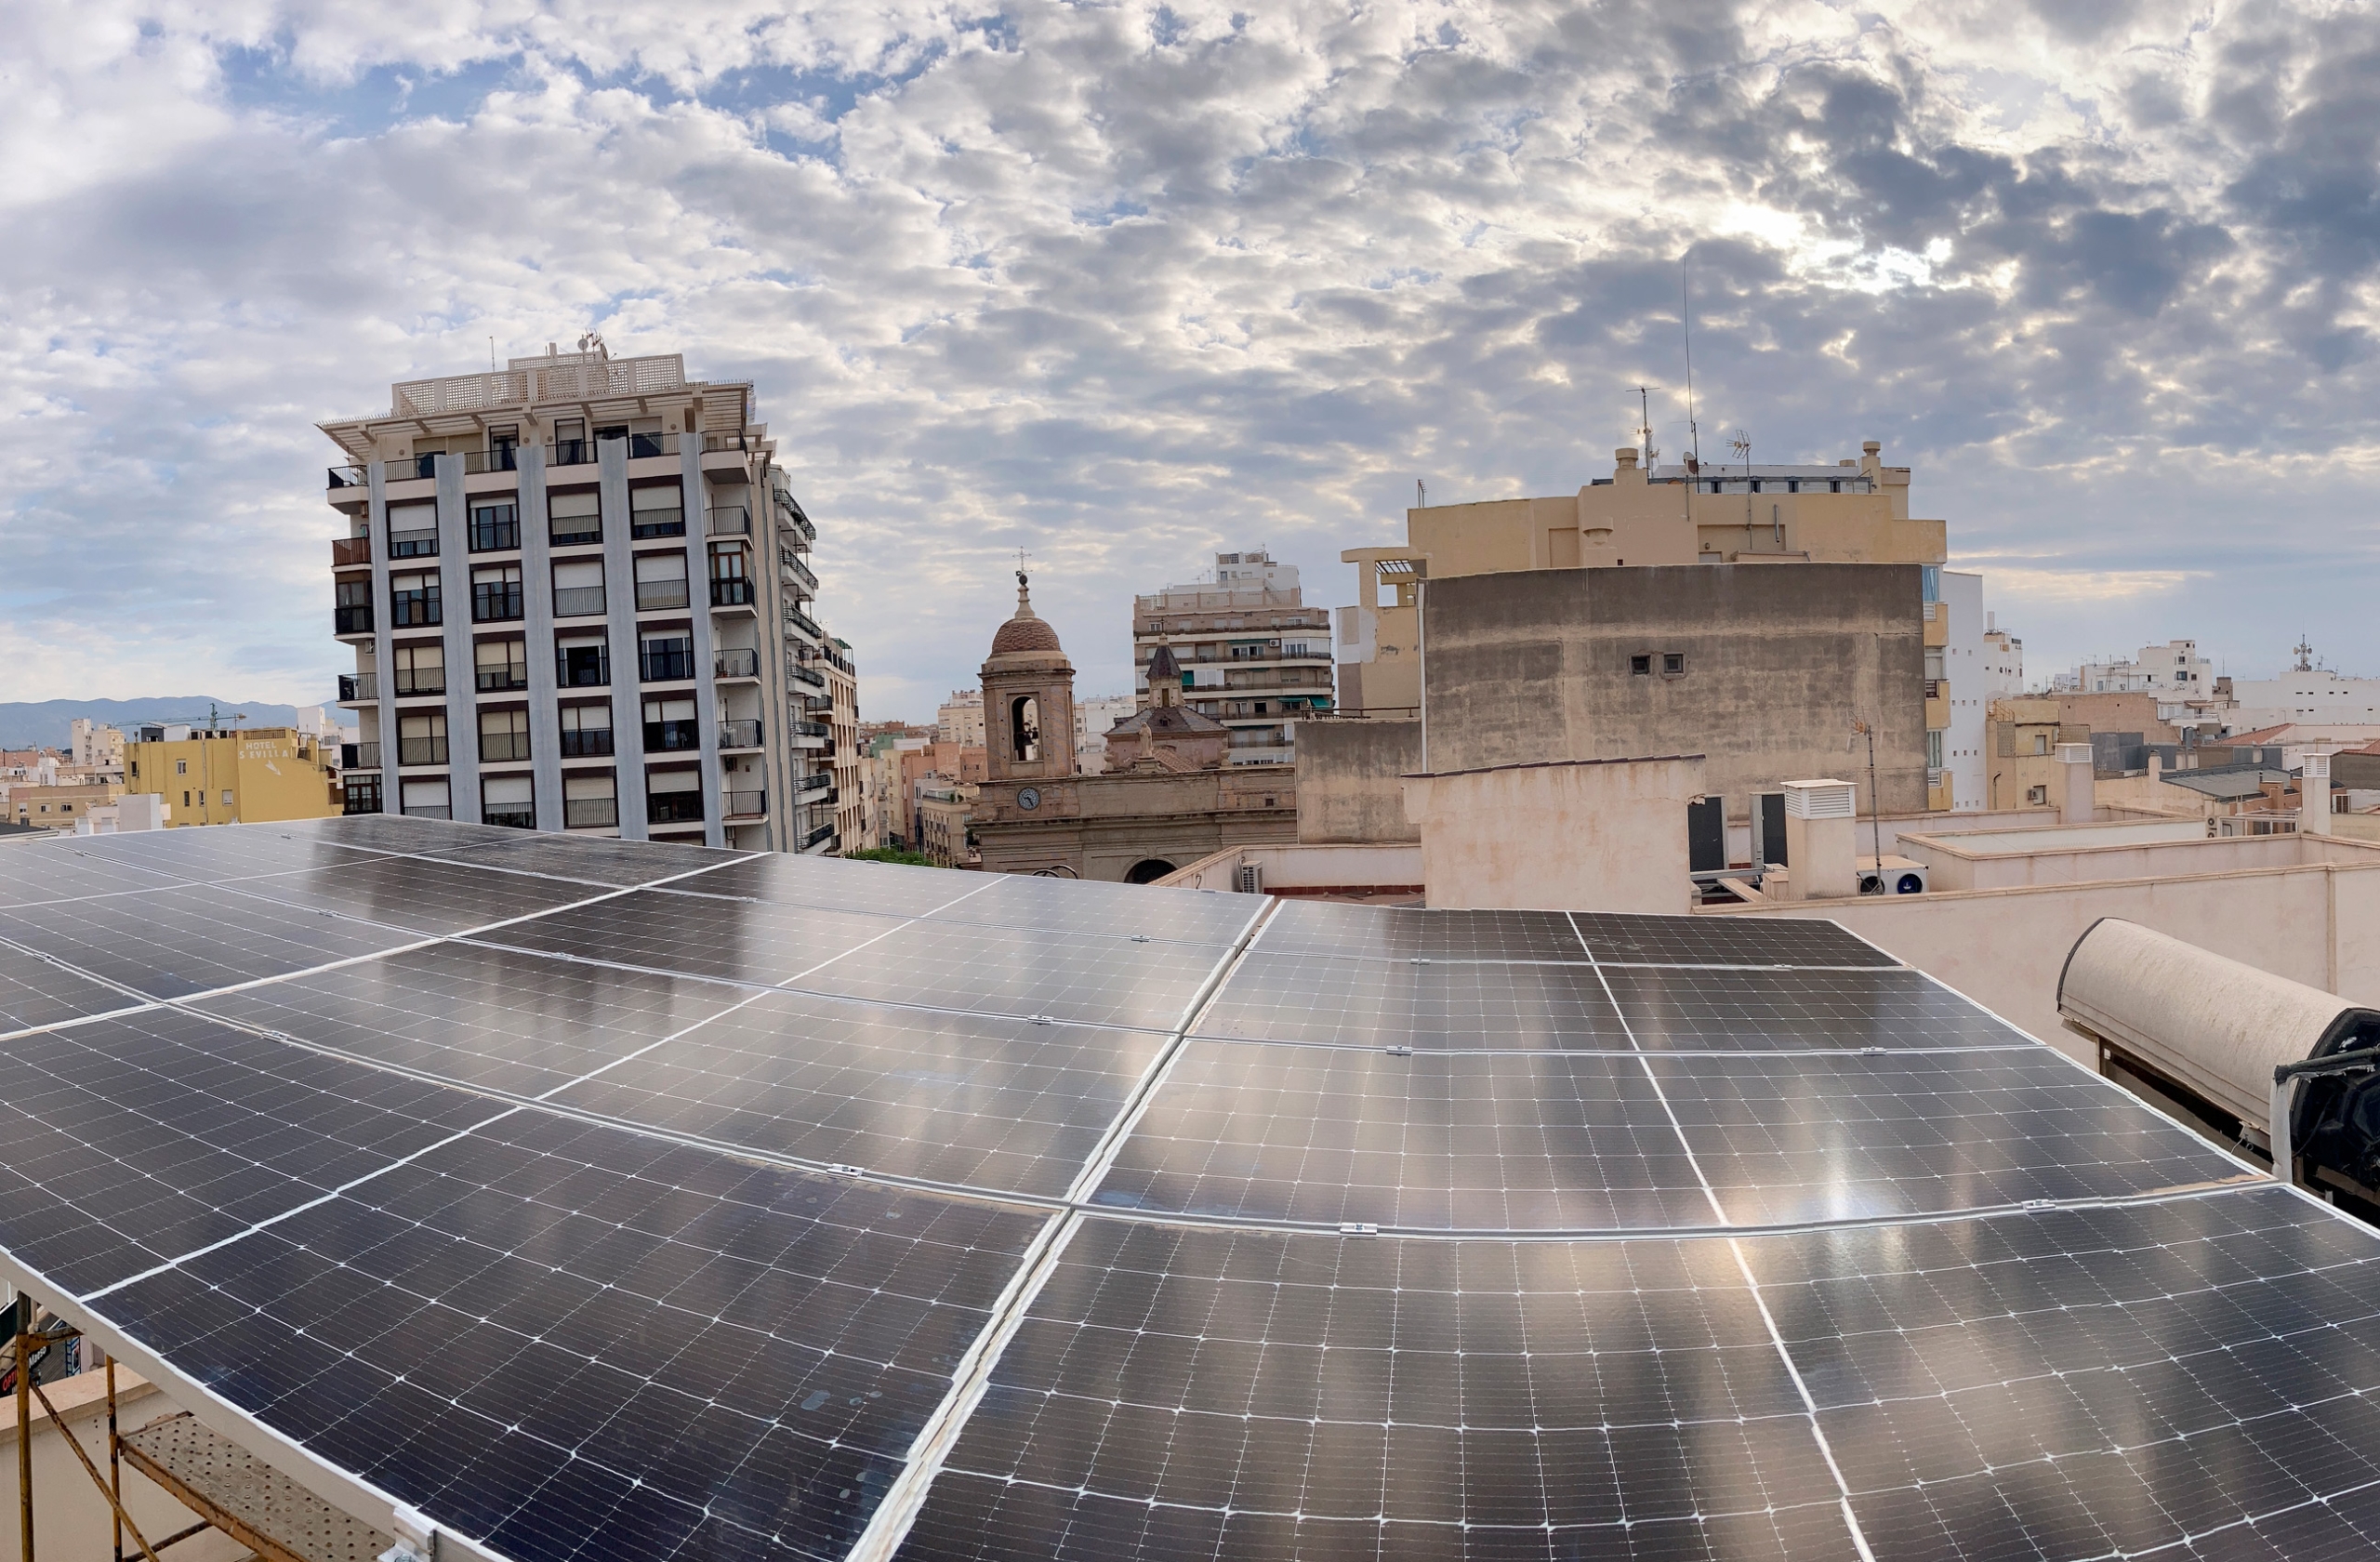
[2058,917,2380,1188]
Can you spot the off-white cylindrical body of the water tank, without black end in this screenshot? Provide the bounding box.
[2058,917,2380,1138]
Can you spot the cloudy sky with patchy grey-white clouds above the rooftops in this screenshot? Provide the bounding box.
[0,0,2380,717]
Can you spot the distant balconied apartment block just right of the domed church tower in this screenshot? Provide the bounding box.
[1133,548,1335,764]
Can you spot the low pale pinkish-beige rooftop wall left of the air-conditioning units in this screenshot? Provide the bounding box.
[1404,757,1701,914]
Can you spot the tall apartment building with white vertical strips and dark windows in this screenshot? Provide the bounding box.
[322,338,838,853]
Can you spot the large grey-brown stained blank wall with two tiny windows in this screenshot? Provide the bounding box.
[1418,564,1925,816]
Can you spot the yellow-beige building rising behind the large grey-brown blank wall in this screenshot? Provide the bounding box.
[1338,441,1988,816]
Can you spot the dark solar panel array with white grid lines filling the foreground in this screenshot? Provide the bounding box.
[0,816,2380,1562]
